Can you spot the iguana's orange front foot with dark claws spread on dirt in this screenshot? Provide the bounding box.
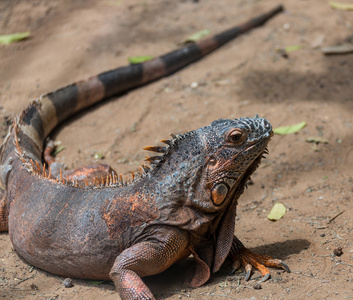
[230,237,290,282]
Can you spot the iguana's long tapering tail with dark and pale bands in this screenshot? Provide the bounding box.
[0,6,283,175]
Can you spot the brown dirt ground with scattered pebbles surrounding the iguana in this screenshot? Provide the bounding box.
[0,0,353,299]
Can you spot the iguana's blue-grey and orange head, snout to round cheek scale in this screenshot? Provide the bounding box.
[200,116,273,208]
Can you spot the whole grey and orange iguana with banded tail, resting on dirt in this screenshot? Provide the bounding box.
[0,7,289,299]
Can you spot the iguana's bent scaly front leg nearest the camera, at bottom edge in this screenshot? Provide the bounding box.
[109,229,191,300]
